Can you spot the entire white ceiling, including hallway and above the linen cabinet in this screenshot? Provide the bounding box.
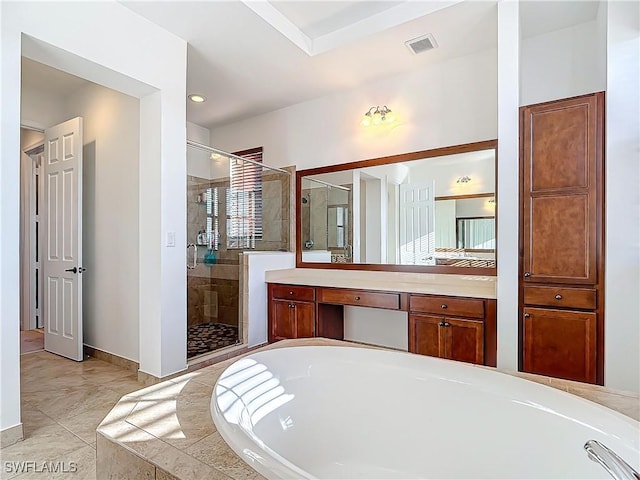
[23,0,599,128]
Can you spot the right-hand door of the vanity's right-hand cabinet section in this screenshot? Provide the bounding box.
[440,318,484,365]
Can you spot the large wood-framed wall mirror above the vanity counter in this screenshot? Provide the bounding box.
[296,140,497,275]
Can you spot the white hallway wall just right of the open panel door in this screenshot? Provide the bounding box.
[66,84,141,362]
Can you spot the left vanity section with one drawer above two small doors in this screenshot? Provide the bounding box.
[268,284,316,343]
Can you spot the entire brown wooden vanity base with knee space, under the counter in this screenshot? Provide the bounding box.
[267,283,496,367]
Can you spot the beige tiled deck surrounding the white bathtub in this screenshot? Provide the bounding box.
[97,338,640,480]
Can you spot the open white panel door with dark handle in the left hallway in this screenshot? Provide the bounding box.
[42,117,84,361]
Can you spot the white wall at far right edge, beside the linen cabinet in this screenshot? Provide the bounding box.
[604,1,640,392]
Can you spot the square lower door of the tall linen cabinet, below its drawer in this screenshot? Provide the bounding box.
[523,308,596,383]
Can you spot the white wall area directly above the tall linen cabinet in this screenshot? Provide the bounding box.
[520,20,606,105]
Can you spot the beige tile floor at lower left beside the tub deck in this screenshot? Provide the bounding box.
[0,351,143,480]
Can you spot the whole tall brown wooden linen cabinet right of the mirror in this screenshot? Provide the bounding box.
[519,92,604,385]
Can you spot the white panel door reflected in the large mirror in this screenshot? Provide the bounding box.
[400,182,436,265]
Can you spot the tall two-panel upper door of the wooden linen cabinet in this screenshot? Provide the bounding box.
[521,93,604,284]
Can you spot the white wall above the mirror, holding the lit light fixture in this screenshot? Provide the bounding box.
[211,50,497,169]
